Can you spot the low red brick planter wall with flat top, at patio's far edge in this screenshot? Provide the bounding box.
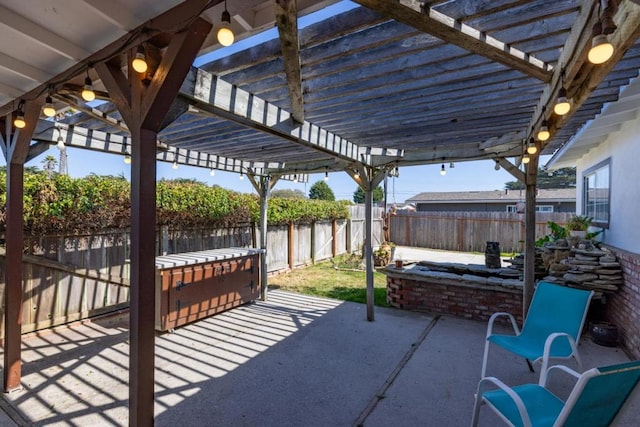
[384,267,522,324]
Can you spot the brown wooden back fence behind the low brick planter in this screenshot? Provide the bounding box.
[389,211,574,252]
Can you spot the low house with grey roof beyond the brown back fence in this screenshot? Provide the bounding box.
[406,188,576,213]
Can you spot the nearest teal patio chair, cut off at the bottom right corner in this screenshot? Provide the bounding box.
[471,361,640,427]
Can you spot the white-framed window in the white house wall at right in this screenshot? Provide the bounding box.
[582,159,611,228]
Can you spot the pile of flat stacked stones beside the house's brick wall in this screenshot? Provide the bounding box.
[544,240,622,292]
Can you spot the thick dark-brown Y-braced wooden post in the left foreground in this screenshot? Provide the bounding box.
[95,15,211,426]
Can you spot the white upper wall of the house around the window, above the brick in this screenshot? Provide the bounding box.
[576,114,640,254]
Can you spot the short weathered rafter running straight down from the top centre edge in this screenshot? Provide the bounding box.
[273,0,304,123]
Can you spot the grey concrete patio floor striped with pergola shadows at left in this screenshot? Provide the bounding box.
[0,290,640,427]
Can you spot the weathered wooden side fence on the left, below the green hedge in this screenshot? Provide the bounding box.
[0,210,382,337]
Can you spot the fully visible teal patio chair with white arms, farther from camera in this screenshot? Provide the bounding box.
[480,281,593,378]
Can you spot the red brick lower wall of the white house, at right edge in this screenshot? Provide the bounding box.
[605,246,640,359]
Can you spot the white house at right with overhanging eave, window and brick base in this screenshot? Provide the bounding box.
[546,78,640,358]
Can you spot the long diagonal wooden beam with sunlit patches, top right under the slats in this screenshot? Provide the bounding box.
[354,0,552,82]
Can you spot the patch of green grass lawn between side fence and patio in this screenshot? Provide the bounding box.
[269,256,389,307]
